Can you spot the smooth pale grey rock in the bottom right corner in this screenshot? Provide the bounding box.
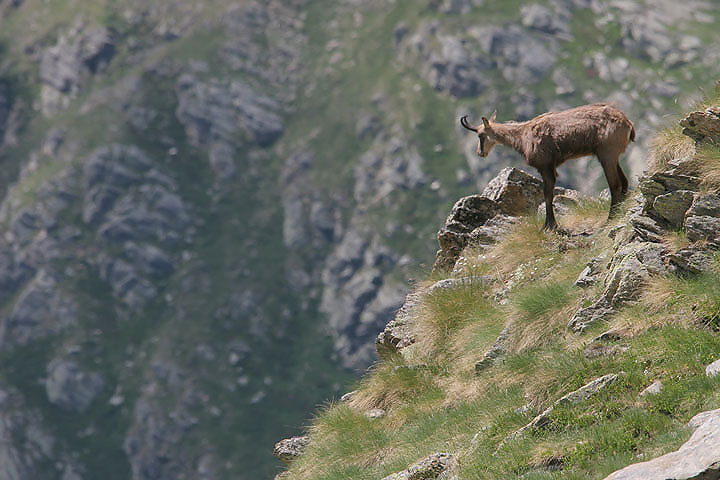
[605,409,720,480]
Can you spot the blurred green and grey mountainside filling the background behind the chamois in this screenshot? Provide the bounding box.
[0,0,720,480]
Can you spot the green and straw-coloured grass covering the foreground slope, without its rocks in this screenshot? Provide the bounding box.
[288,97,720,480]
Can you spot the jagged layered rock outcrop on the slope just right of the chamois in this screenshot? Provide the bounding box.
[568,150,720,332]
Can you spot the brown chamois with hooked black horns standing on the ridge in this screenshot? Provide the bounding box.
[460,103,635,230]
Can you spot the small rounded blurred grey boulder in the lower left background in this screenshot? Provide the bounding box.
[45,358,105,413]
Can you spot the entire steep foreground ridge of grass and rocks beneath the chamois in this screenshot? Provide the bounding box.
[277,90,720,480]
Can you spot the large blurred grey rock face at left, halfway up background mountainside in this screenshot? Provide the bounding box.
[82,145,191,308]
